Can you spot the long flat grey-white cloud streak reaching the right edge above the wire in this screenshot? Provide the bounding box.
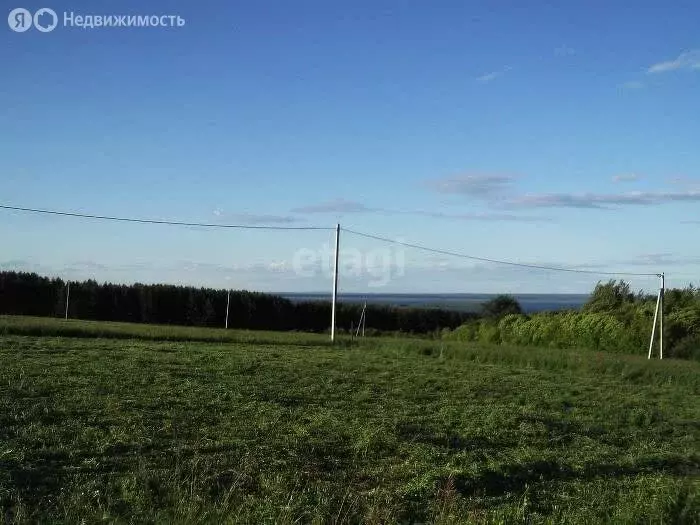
[506,191,700,209]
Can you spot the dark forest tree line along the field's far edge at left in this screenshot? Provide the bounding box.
[0,272,477,334]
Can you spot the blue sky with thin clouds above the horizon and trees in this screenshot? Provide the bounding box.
[0,0,700,292]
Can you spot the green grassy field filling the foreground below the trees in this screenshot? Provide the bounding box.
[0,317,700,524]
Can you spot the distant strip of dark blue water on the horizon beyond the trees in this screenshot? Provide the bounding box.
[277,293,589,313]
